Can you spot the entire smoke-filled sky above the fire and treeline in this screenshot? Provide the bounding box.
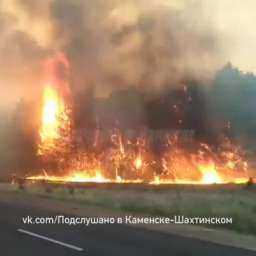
[0,0,256,106]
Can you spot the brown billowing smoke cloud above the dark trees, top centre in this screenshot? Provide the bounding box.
[51,0,222,93]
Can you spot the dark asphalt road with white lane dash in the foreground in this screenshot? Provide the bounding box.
[0,202,256,256]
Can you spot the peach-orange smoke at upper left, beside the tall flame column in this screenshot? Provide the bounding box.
[0,0,50,107]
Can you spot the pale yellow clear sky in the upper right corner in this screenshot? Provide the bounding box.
[202,0,256,73]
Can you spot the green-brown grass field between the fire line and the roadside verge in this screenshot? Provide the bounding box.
[5,184,256,235]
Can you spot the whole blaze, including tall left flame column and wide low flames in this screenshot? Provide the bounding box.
[27,53,252,185]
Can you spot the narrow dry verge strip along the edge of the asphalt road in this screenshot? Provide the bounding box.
[0,184,256,251]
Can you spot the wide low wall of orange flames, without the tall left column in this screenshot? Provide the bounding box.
[28,127,249,185]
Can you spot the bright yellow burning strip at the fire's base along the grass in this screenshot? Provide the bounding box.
[27,152,249,185]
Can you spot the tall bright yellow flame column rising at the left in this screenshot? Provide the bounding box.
[38,54,71,158]
